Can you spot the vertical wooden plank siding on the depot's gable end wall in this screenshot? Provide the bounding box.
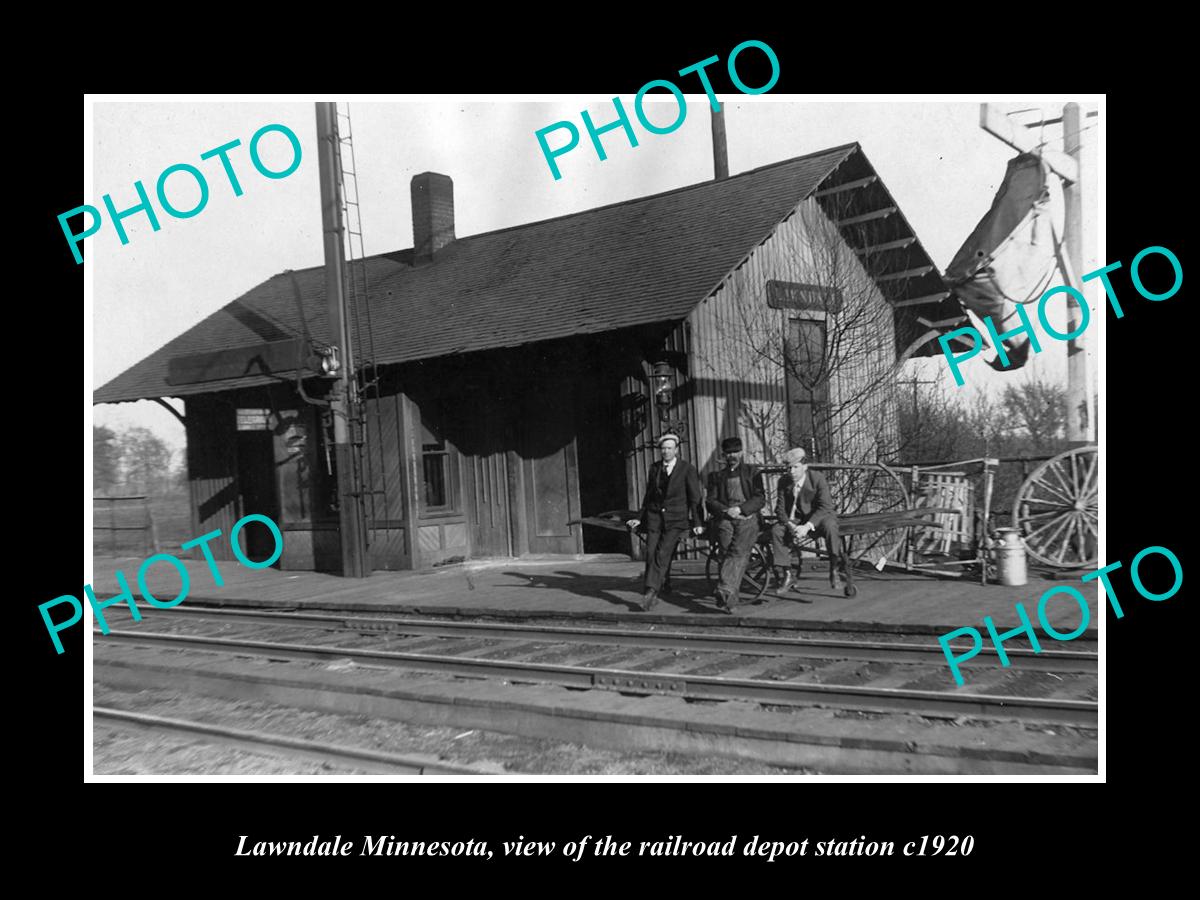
[686,200,898,470]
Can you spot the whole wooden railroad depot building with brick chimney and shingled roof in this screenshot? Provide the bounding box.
[95,144,962,571]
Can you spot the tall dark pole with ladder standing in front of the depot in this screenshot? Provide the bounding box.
[317,103,370,578]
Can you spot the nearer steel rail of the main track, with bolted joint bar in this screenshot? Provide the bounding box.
[92,629,1098,727]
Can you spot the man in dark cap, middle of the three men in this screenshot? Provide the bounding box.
[704,438,767,613]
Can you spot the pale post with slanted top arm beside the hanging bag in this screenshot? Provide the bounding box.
[979,102,1104,446]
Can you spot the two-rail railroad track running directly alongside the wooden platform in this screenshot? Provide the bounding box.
[96,610,1098,728]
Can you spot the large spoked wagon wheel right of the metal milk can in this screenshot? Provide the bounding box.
[1013,446,1100,569]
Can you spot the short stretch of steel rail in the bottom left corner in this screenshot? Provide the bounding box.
[92,707,493,775]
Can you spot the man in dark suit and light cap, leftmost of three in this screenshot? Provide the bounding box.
[625,433,704,612]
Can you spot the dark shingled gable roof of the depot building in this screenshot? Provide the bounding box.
[94,144,961,403]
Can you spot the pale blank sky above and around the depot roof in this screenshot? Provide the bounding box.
[88,95,1108,458]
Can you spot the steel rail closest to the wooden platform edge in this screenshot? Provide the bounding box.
[150,607,1098,673]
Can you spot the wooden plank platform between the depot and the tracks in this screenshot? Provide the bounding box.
[88,556,1097,648]
